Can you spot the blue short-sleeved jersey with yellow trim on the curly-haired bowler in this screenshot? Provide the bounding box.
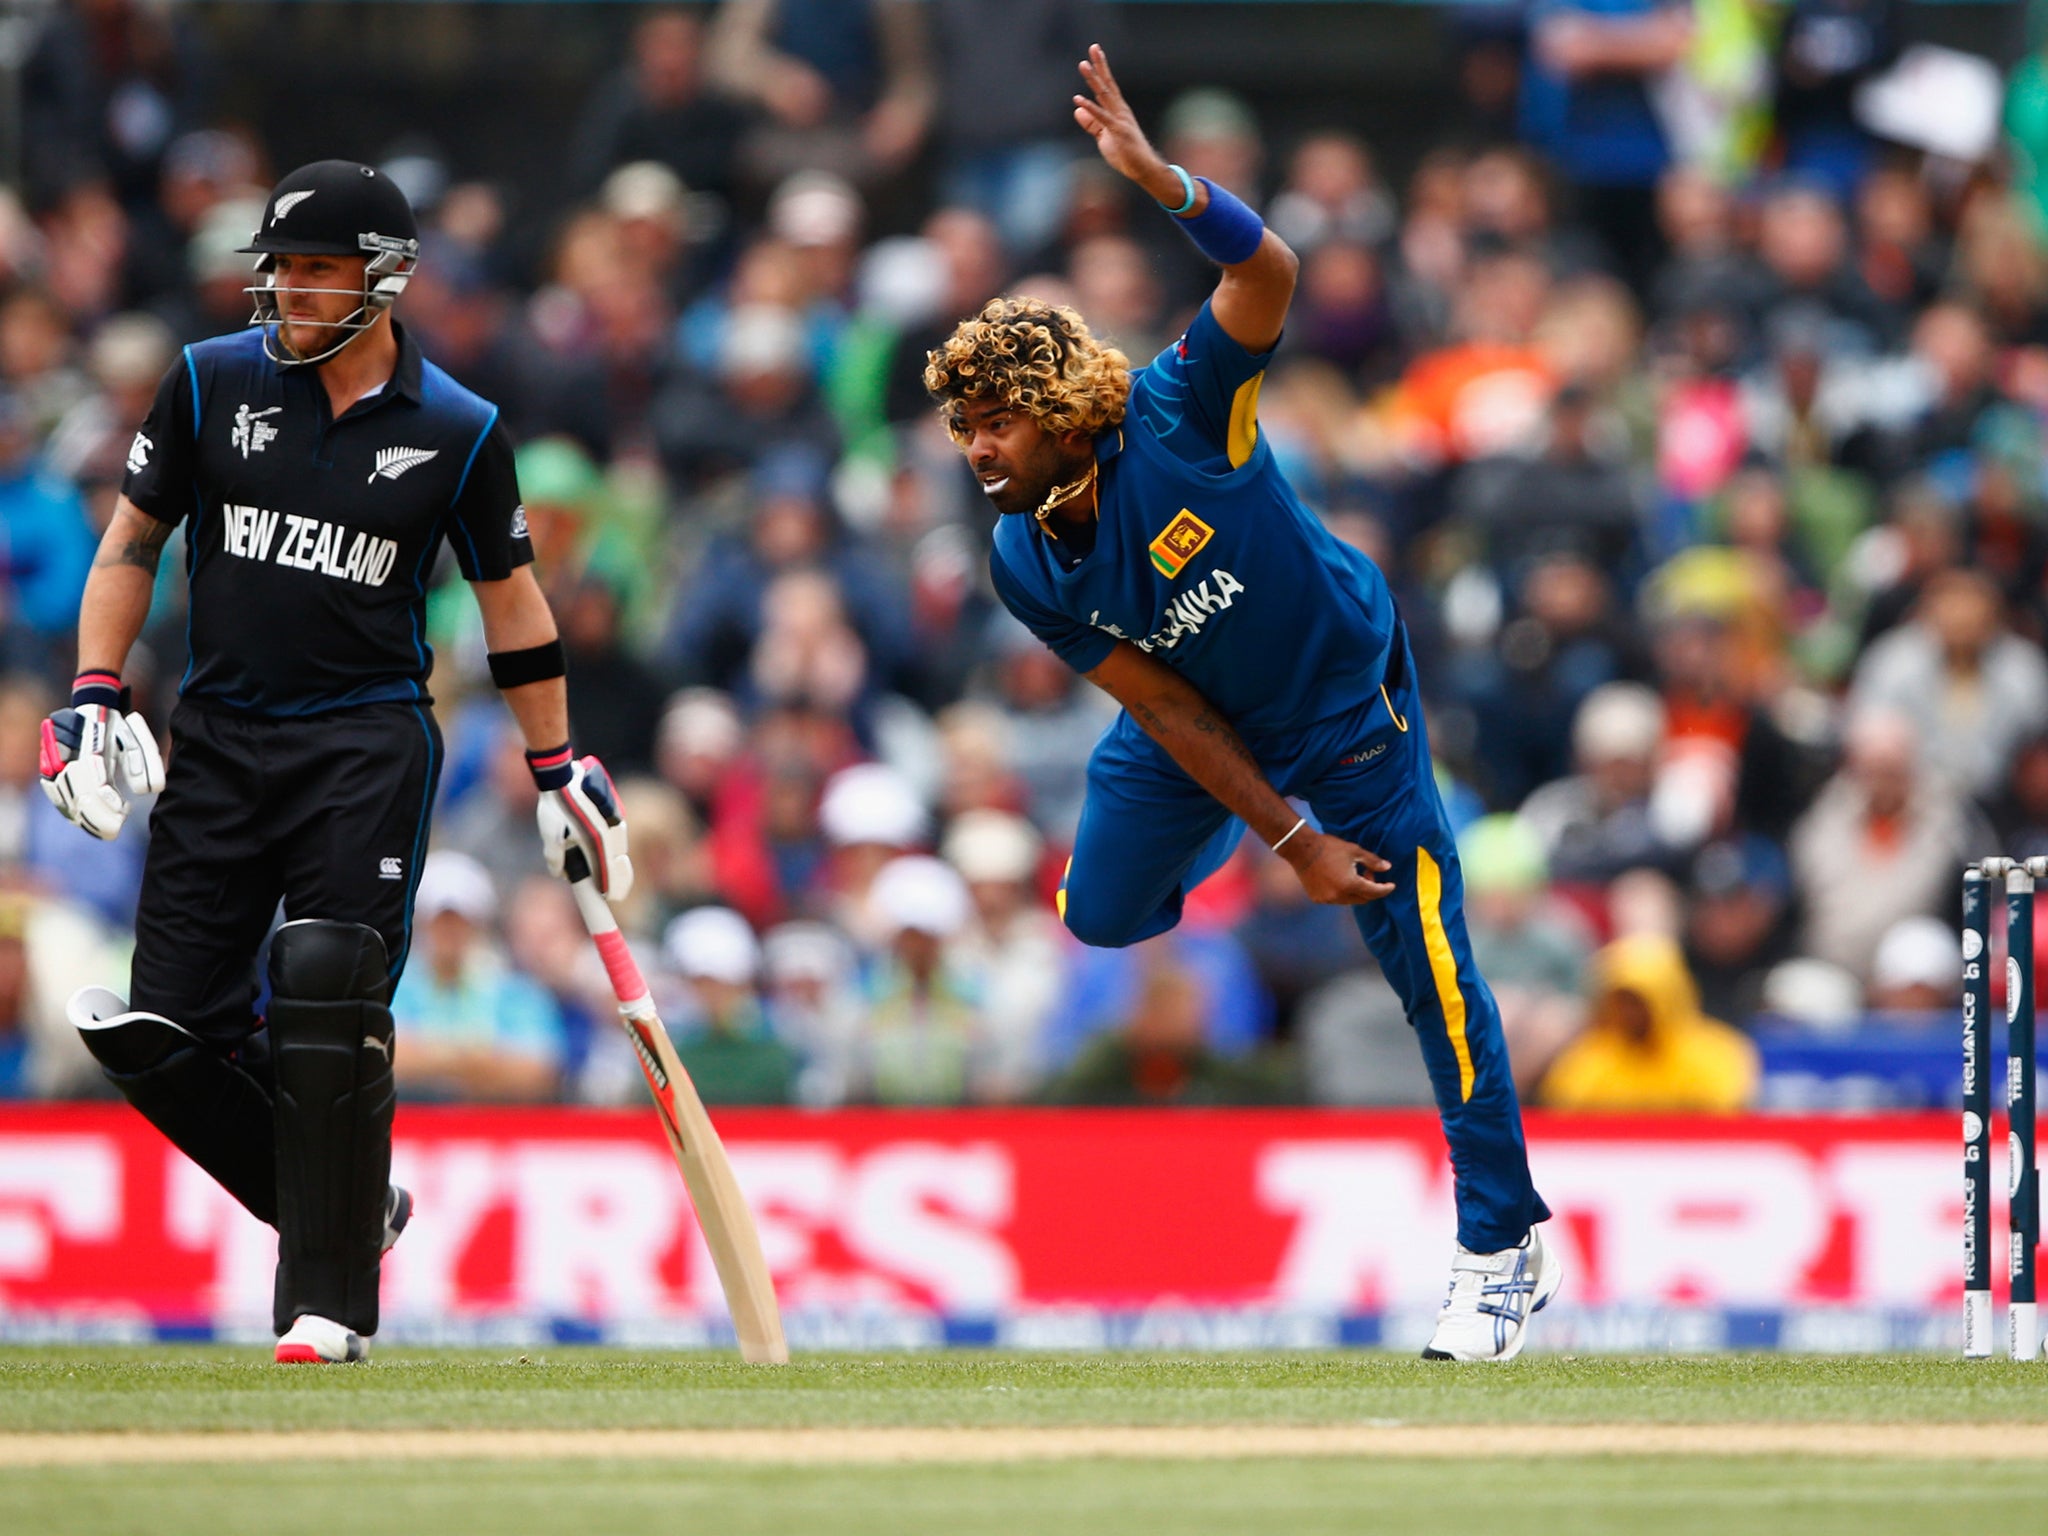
[989,303,1395,772]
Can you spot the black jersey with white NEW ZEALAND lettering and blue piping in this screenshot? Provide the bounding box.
[121,330,532,719]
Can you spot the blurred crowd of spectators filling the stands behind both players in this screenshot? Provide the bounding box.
[0,0,2048,1110]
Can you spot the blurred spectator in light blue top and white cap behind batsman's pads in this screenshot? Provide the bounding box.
[391,850,565,1102]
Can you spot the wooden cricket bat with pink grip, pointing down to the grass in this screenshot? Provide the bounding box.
[569,879,788,1366]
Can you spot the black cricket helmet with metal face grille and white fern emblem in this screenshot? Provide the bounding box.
[242,160,420,362]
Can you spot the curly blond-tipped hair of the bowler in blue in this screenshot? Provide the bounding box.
[924,297,1130,442]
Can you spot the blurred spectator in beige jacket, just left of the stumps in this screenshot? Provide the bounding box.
[1790,709,1991,983]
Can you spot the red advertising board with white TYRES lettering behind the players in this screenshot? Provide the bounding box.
[0,1106,2003,1348]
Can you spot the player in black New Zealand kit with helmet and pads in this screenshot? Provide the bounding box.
[41,160,631,1362]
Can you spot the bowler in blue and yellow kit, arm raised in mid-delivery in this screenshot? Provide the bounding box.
[924,47,1561,1360]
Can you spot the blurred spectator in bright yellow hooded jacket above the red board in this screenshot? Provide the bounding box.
[1536,934,1757,1114]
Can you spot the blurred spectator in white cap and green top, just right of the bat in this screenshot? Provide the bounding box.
[662,907,797,1104]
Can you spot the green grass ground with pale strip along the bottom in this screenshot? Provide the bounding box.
[0,1346,2048,1536]
